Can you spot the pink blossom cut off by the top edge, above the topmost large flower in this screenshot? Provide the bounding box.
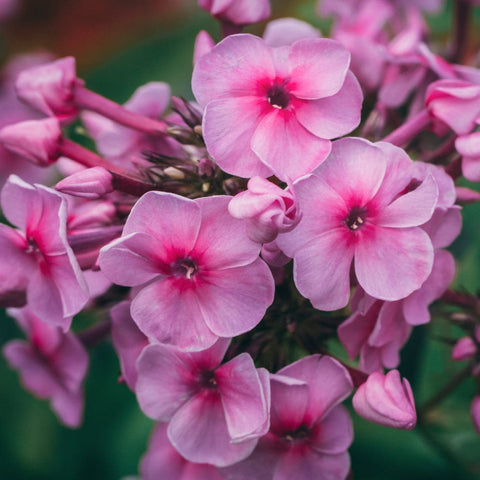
[198,0,270,25]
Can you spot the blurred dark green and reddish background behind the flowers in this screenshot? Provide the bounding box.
[0,0,480,480]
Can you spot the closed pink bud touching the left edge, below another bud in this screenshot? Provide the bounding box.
[0,118,62,167]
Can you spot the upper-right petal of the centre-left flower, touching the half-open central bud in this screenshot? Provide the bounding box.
[195,196,260,270]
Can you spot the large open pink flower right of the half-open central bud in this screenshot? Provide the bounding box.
[276,138,438,310]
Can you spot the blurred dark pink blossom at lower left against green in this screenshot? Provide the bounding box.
[3,309,88,427]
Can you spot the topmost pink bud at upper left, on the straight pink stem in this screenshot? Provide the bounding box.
[15,57,83,120]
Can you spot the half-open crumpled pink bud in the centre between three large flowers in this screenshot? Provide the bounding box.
[228,177,301,243]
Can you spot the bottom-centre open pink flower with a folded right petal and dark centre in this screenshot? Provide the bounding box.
[135,339,270,466]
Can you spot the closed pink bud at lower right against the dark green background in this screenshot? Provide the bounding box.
[352,370,417,430]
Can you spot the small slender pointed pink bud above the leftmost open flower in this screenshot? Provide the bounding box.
[55,167,114,199]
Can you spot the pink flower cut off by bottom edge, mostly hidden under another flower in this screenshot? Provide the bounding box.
[140,423,224,480]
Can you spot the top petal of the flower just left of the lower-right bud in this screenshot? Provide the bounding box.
[278,355,353,425]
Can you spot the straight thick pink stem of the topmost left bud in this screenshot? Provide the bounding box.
[75,87,168,135]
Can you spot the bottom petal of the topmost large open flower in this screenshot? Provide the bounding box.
[250,108,331,181]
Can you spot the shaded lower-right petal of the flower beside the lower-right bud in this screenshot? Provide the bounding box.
[309,404,353,455]
